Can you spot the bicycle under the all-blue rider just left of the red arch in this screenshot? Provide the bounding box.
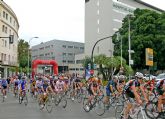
[19,90,28,106]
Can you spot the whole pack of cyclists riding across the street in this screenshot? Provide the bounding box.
[0,72,165,119]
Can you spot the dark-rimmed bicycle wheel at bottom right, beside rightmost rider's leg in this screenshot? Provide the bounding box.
[145,102,159,119]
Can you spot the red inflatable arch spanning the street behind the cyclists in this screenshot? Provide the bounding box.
[32,59,58,78]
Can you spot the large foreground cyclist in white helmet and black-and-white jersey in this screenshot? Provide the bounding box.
[124,72,148,119]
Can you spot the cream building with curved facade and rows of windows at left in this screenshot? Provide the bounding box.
[0,0,19,78]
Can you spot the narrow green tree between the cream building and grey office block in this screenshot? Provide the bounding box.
[18,39,29,68]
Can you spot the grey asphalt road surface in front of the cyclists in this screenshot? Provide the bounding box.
[0,93,115,119]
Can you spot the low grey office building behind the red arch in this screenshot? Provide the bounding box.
[31,40,84,73]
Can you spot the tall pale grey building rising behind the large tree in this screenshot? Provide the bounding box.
[85,0,163,56]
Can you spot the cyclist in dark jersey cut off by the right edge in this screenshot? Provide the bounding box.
[156,79,165,115]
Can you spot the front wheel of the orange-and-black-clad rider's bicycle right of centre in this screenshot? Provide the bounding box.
[94,100,105,116]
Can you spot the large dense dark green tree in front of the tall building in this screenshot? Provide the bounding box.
[113,9,165,70]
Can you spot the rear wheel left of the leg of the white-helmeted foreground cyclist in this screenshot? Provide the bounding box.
[115,105,124,119]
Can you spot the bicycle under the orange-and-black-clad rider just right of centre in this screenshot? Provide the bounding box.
[83,95,105,116]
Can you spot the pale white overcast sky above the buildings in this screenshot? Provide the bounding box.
[4,0,165,46]
